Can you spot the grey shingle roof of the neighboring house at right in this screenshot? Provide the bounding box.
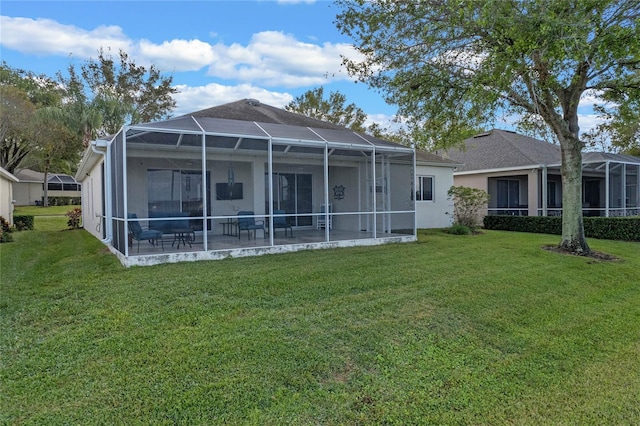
[446,129,561,172]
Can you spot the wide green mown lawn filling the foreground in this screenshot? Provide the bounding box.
[0,218,640,425]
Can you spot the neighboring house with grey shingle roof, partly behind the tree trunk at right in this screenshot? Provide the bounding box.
[445,129,640,216]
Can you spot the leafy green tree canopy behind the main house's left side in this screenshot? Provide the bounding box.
[0,49,176,178]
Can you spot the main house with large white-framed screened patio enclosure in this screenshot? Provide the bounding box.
[76,99,453,266]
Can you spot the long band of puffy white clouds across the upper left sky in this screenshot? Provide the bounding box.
[0,16,358,88]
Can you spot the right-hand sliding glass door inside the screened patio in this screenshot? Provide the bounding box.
[265,173,313,226]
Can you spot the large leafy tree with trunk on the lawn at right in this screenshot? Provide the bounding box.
[336,0,640,254]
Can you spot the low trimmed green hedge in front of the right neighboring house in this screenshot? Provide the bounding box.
[483,215,640,241]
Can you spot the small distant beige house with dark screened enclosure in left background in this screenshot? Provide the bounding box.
[14,169,80,206]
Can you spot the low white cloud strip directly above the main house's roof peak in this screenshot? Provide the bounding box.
[173,83,293,116]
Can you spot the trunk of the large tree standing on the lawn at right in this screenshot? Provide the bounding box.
[560,137,591,255]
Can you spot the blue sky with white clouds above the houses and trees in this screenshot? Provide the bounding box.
[0,0,597,136]
